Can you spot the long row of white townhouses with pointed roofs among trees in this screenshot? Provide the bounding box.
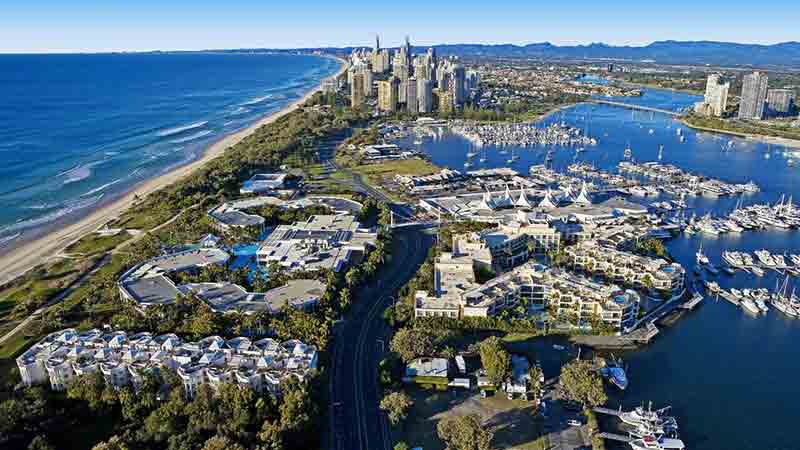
[17,328,317,398]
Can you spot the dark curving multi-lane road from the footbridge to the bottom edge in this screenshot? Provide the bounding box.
[326,230,433,450]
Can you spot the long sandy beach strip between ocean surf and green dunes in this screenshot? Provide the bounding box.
[0,56,347,284]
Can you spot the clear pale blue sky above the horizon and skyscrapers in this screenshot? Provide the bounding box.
[0,0,800,53]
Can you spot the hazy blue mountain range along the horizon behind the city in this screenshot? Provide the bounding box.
[292,41,800,68]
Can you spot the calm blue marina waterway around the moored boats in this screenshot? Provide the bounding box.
[406,89,800,450]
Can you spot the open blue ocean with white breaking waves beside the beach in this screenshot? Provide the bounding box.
[0,53,339,248]
